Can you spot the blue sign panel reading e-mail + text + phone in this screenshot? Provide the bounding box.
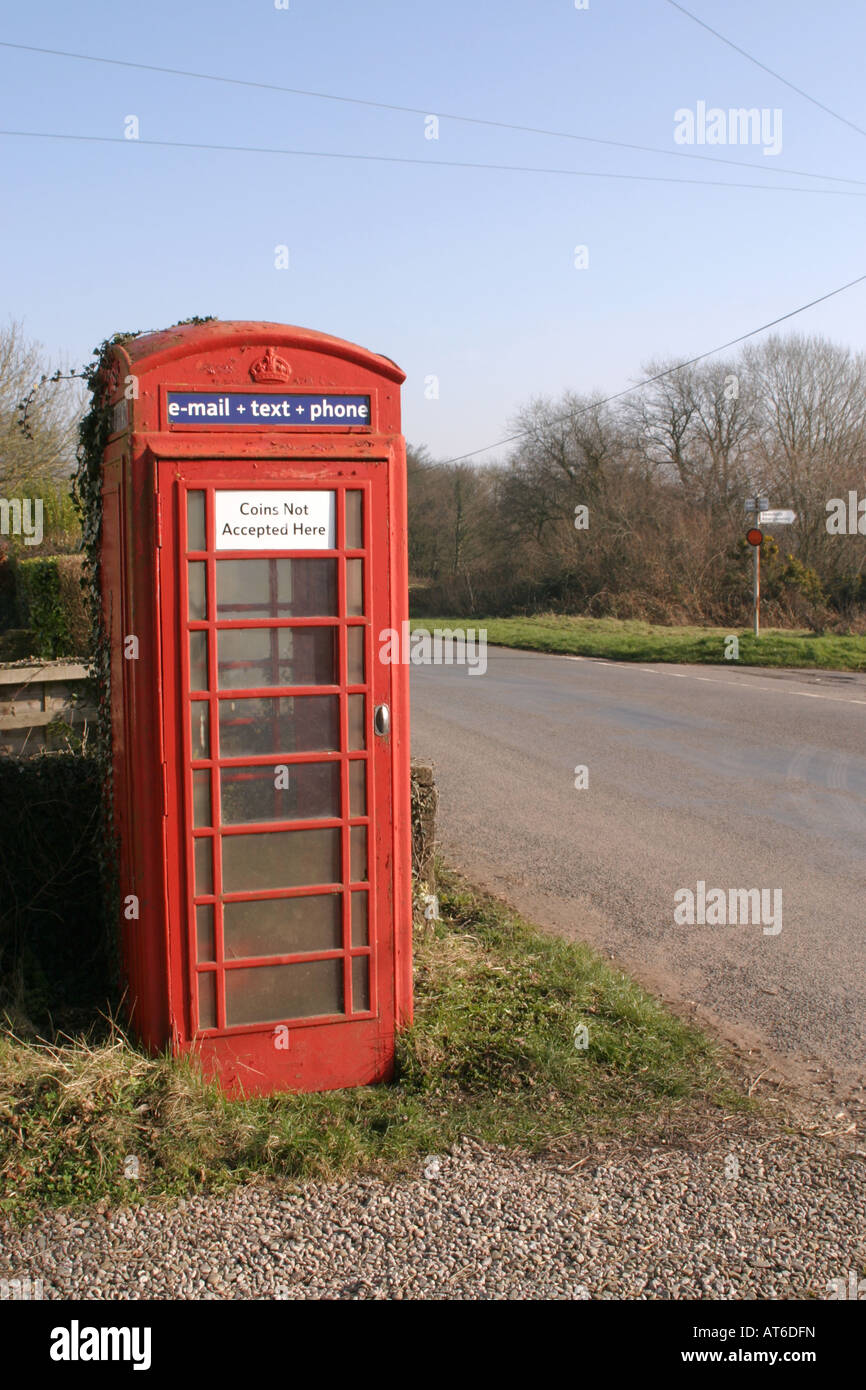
[168,391,370,430]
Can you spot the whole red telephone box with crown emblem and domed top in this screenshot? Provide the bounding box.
[101,321,411,1094]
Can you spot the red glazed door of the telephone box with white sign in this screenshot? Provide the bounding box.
[158,460,395,1093]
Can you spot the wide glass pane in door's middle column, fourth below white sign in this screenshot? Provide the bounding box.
[220,763,340,826]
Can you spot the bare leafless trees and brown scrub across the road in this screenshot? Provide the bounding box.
[409,335,866,631]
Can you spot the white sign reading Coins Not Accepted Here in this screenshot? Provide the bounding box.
[215,488,336,550]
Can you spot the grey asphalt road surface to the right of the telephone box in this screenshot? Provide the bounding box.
[411,648,866,1099]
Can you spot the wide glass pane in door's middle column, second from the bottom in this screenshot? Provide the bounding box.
[222,892,341,960]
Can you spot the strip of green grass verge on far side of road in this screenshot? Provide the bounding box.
[411,614,866,671]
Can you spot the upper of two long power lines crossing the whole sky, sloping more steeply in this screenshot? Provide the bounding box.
[0,39,866,185]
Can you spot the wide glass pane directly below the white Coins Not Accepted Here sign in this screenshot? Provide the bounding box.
[217,557,336,619]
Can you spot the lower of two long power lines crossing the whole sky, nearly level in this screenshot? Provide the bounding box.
[0,131,866,197]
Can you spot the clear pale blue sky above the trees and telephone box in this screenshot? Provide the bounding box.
[0,0,866,457]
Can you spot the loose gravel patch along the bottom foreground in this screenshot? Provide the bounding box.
[0,1137,866,1300]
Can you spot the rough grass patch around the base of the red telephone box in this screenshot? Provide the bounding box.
[0,877,751,1219]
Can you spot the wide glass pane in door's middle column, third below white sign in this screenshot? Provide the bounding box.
[220,695,339,758]
